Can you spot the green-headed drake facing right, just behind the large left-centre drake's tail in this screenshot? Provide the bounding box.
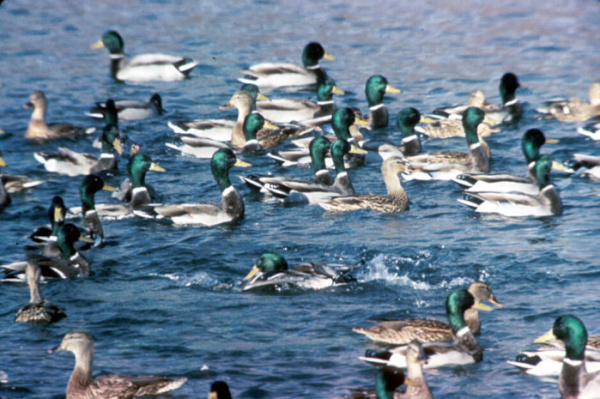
[78,152,165,218]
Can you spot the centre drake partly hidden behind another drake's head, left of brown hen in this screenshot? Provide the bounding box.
[240,137,333,193]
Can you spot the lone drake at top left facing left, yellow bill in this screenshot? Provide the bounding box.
[91,30,198,82]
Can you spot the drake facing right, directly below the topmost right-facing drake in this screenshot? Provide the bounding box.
[256,76,344,126]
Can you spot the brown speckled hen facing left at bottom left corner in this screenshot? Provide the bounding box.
[48,330,187,399]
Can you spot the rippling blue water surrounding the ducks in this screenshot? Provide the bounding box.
[0,0,600,398]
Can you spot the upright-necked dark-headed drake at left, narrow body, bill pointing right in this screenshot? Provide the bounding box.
[79,174,115,247]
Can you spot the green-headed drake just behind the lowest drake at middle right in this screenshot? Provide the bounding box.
[452,129,565,195]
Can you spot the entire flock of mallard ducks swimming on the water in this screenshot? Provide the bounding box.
[0,19,600,399]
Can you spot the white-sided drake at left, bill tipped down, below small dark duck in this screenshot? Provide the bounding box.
[33,120,123,176]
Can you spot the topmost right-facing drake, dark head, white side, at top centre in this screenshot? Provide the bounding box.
[238,42,335,89]
